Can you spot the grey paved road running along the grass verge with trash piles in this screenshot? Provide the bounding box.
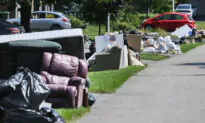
[76,45,205,123]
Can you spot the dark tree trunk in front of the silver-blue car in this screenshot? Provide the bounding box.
[20,0,31,32]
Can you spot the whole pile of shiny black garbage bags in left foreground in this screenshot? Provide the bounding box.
[0,68,65,123]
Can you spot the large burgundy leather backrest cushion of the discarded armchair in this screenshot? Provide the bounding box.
[50,53,79,77]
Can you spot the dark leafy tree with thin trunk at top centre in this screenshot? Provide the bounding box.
[81,0,129,34]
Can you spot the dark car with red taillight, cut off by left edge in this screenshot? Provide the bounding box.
[0,20,21,35]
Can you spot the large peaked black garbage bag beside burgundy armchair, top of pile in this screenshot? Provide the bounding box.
[0,68,50,110]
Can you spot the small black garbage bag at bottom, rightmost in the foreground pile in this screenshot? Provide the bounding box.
[40,107,65,123]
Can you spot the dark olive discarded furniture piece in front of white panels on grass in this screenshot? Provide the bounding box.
[94,46,122,71]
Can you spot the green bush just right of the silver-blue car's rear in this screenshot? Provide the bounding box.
[67,15,84,28]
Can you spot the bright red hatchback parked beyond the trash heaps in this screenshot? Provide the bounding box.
[142,12,196,31]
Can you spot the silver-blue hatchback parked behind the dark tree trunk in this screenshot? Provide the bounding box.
[7,11,71,31]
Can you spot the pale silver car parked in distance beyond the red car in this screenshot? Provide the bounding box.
[176,4,198,18]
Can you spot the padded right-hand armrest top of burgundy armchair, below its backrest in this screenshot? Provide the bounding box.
[68,76,86,87]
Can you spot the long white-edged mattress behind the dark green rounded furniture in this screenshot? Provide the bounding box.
[0,29,85,59]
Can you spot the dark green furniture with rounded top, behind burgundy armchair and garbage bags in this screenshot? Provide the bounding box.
[0,40,62,78]
